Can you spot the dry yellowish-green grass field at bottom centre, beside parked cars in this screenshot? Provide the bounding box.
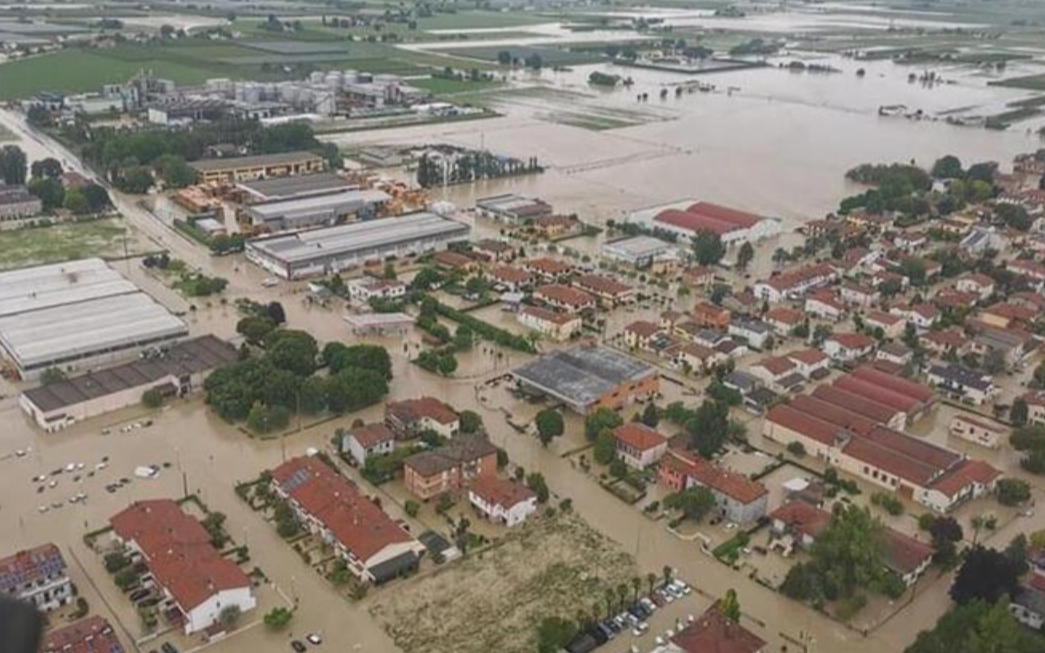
[370,513,637,653]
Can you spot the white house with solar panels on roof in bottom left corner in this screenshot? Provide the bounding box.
[0,544,75,612]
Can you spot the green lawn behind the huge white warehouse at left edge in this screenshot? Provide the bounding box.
[0,218,135,270]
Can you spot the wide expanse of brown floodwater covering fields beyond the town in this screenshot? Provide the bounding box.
[324,53,1042,226]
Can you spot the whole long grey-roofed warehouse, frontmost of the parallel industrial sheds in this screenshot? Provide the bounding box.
[247,213,471,279]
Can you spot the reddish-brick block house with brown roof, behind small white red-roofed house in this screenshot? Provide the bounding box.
[403,435,497,502]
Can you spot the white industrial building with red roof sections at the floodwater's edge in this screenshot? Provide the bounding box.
[627,200,781,246]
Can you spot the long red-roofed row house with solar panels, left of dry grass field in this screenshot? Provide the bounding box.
[272,456,424,585]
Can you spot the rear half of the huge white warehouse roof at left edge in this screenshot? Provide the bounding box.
[0,258,138,318]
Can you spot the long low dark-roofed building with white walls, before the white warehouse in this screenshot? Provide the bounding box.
[20,335,239,432]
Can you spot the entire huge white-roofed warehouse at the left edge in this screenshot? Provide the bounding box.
[0,258,188,379]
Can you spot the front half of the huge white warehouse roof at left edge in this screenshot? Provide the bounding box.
[0,291,188,370]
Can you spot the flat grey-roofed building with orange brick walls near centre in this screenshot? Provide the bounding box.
[511,345,659,415]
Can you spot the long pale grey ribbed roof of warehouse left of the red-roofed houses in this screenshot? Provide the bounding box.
[248,213,469,263]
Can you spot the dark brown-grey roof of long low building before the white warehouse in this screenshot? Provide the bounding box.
[24,335,239,413]
